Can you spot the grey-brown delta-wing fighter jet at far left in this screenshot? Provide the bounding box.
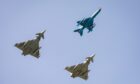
[15,30,46,58]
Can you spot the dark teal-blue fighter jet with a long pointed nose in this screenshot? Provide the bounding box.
[74,8,101,36]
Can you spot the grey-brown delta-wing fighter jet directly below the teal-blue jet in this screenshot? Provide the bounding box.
[65,54,95,80]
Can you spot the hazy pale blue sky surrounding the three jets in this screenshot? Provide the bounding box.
[0,0,140,84]
